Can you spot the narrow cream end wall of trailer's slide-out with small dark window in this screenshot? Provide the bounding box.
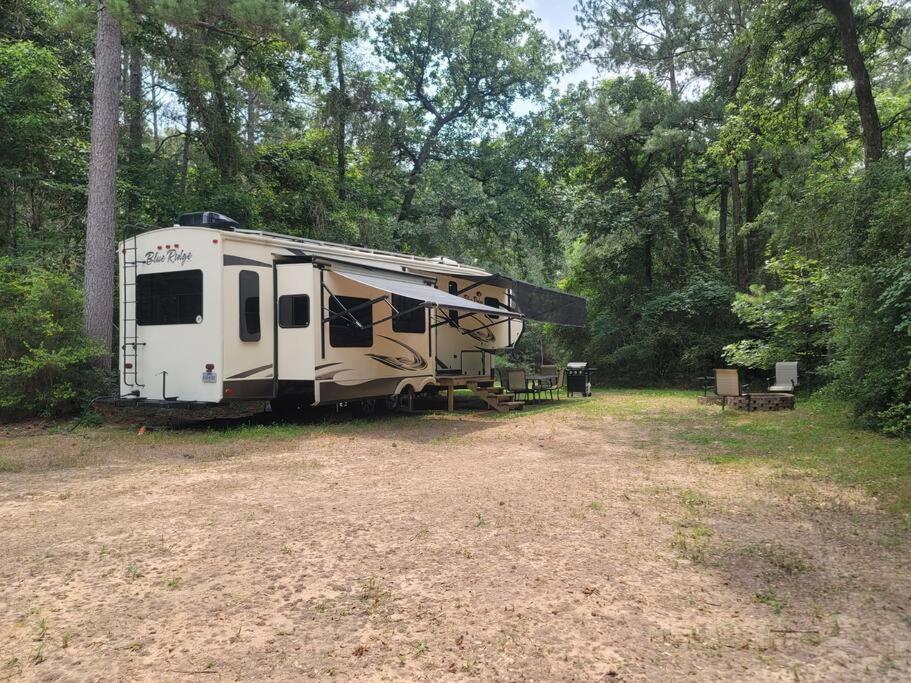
[275,262,320,381]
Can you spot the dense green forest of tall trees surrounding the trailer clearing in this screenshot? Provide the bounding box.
[0,0,911,436]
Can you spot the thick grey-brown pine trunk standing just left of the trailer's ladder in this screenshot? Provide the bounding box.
[83,0,121,368]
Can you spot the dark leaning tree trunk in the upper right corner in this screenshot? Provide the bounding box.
[821,0,883,167]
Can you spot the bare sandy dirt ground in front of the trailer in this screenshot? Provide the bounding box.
[0,397,911,681]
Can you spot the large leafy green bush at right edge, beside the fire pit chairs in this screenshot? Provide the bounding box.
[760,159,911,436]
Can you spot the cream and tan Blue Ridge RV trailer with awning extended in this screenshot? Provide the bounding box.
[118,212,585,410]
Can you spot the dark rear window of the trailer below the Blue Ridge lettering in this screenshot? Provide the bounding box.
[136,270,202,325]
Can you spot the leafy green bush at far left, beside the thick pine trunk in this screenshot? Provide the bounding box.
[0,259,105,418]
